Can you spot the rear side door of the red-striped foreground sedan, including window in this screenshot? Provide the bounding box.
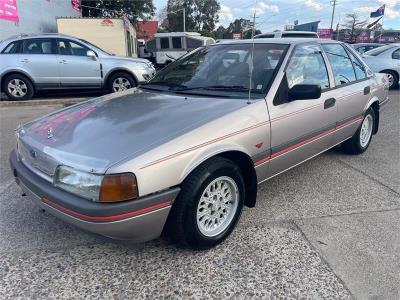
[322,43,373,144]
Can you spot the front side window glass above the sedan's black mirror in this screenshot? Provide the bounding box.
[286,45,329,90]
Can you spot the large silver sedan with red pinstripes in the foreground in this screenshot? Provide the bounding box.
[10,38,389,248]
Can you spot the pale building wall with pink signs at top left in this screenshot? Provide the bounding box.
[0,0,81,40]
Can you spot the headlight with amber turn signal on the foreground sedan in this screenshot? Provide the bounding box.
[54,166,138,202]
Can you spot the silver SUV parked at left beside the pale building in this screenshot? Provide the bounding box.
[0,34,155,100]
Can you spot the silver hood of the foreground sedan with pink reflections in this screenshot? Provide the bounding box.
[18,89,250,176]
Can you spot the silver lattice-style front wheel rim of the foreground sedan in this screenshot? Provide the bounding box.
[196,176,239,237]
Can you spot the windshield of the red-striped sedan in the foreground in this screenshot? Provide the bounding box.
[142,43,289,98]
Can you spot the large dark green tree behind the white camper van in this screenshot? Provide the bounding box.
[161,0,220,35]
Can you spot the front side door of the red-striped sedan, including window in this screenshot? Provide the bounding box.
[268,43,337,176]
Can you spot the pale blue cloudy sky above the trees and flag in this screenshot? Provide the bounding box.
[154,0,400,32]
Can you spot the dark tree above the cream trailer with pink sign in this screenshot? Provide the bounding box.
[81,0,155,21]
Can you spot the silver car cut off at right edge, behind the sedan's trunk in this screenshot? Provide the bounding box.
[363,44,400,89]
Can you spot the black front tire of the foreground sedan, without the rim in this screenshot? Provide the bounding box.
[165,157,245,249]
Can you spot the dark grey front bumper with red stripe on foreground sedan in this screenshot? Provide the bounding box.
[10,151,179,242]
